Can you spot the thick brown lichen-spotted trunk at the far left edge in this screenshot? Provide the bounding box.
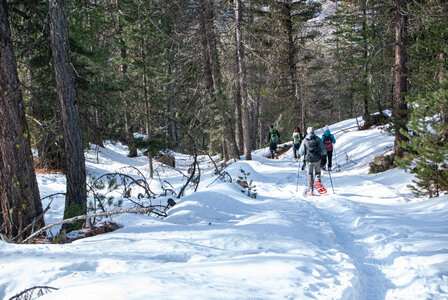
[0,0,45,239]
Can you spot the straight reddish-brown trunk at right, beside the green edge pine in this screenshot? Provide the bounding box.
[393,0,408,157]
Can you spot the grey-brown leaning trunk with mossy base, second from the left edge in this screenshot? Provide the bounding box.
[49,0,87,231]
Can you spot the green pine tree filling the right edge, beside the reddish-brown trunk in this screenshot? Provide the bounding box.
[398,1,448,197]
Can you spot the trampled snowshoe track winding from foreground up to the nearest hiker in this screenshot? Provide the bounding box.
[238,161,391,300]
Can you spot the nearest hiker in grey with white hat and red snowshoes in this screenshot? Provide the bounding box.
[299,127,327,195]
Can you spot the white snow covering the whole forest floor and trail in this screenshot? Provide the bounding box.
[0,119,448,300]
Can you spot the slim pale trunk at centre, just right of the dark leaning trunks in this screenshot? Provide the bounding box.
[235,0,252,160]
